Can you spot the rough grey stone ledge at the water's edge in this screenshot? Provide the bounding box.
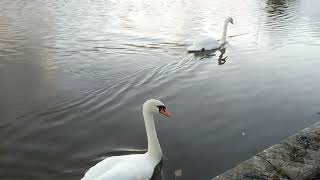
[212,122,320,180]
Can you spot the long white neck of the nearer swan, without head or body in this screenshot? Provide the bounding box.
[143,111,162,160]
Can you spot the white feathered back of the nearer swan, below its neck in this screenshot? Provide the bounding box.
[81,154,154,180]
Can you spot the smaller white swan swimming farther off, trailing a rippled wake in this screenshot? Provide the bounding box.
[187,17,233,52]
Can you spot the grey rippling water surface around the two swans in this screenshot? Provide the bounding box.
[0,0,320,180]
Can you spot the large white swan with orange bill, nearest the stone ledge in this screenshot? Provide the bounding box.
[82,99,171,180]
